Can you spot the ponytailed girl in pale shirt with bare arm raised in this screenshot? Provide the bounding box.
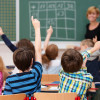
[42,26,61,74]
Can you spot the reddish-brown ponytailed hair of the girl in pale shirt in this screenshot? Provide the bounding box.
[42,44,58,65]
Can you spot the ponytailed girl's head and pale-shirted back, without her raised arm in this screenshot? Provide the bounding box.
[42,44,61,74]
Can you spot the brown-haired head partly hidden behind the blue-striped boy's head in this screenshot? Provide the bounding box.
[16,39,35,59]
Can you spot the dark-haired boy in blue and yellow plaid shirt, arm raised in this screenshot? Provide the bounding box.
[59,42,100,100]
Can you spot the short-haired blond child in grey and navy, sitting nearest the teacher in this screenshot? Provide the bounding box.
[80,39,100,82]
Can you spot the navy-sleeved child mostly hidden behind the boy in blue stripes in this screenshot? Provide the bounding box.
[0,27,35,74]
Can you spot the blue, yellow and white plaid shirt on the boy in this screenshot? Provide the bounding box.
[59,68,93,100]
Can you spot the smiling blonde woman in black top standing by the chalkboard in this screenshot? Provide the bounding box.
[85,6,100,43]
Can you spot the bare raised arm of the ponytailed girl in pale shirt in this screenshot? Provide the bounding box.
[43,26,53,51]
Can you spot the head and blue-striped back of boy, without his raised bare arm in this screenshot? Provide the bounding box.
[4,49,42,94]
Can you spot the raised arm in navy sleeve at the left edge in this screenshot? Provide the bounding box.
[0,27,17,52]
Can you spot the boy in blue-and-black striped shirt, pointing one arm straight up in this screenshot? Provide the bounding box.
[4,17,42,96]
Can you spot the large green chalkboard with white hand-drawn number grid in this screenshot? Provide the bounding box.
[20,0,100,41]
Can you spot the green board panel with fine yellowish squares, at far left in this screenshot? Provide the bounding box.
[0,0,16,41]
